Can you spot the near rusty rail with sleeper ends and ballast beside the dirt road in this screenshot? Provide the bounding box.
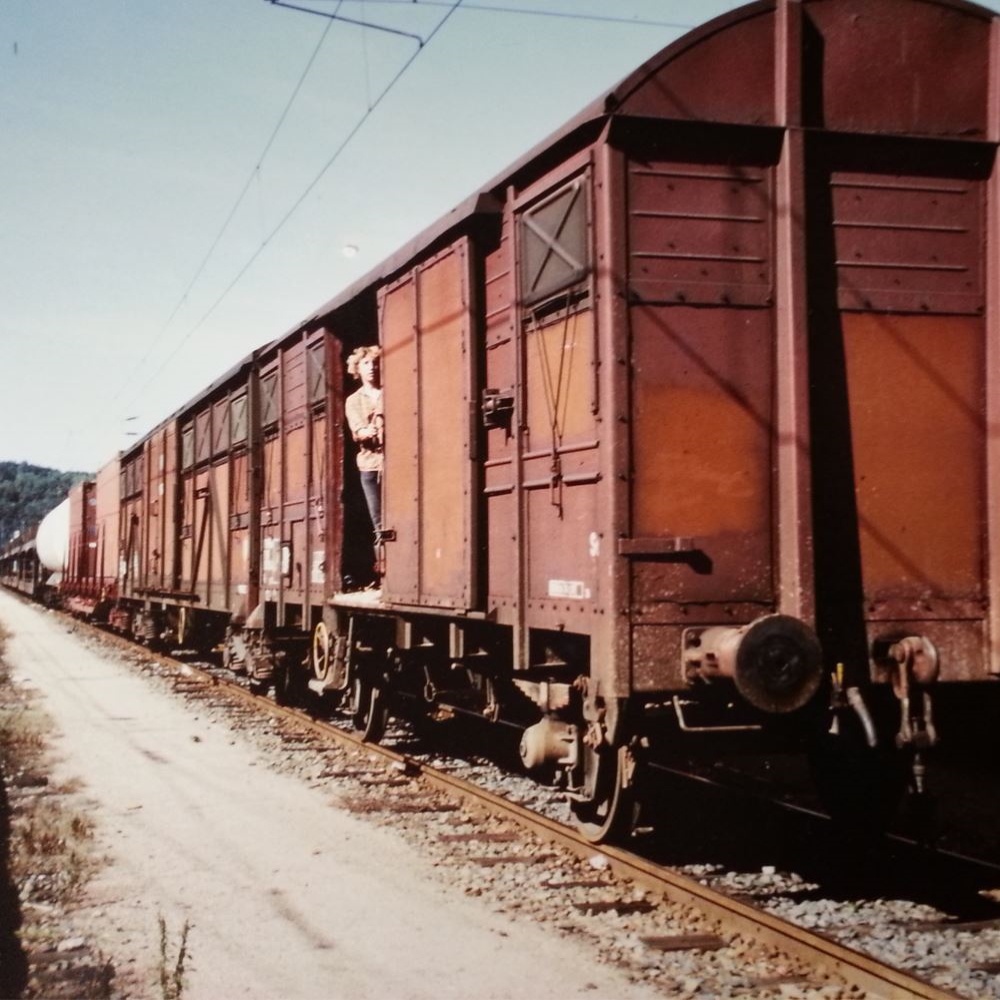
[62,626,993,998]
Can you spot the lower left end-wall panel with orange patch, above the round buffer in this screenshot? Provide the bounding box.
[631,306,774,603]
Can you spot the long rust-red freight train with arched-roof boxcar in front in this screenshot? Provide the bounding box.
[5,0,1000,841]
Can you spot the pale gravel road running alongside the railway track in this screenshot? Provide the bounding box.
[0,592,662,1000]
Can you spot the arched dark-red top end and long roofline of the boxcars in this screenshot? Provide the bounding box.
[135,0,1000,452]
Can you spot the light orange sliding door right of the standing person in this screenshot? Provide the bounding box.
[380,240,478,608]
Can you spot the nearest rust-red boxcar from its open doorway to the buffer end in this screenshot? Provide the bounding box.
[298,0,1000,844]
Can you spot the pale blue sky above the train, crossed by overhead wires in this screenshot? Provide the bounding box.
[0,0,1000,470]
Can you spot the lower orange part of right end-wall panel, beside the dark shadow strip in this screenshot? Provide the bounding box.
[814,313,986,679]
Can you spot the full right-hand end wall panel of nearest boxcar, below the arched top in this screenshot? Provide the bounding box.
[806,137,992,680]
